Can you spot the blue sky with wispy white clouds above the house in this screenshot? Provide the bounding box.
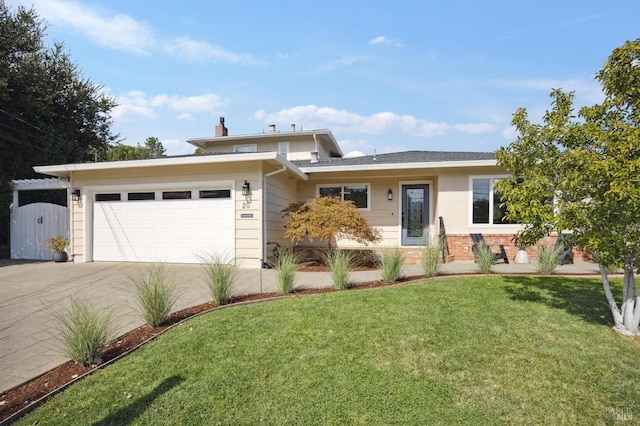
[5,0,640,155]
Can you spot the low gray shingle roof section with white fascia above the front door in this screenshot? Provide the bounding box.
[292,151,496,173]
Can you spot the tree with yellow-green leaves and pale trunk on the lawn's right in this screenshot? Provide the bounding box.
[496,39,640,335]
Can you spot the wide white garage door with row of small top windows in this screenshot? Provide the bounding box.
[93,189,235,263]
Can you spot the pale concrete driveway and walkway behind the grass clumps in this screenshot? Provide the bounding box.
[0,260,598,393]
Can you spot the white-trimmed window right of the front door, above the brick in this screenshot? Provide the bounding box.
[471,176,513,225]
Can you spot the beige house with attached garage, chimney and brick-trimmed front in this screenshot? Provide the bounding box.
[34,118,564,268]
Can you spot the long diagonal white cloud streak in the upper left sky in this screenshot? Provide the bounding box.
[23,0,262,64]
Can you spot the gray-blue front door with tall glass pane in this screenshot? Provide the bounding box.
[402,184,429,246]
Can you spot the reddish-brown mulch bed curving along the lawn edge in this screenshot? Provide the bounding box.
[0,262,424,422]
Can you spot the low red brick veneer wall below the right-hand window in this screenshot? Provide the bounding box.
[447,234,592,262]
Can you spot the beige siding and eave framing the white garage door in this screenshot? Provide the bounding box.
[72,162,262,267]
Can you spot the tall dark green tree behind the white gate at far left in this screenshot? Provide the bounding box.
[0,0,116,245]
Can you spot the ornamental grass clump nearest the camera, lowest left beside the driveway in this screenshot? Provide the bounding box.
[53,299,114,367]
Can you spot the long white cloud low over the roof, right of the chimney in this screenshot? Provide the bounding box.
[254,105,495,138]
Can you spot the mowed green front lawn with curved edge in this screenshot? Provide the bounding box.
[20,276,640,425]
